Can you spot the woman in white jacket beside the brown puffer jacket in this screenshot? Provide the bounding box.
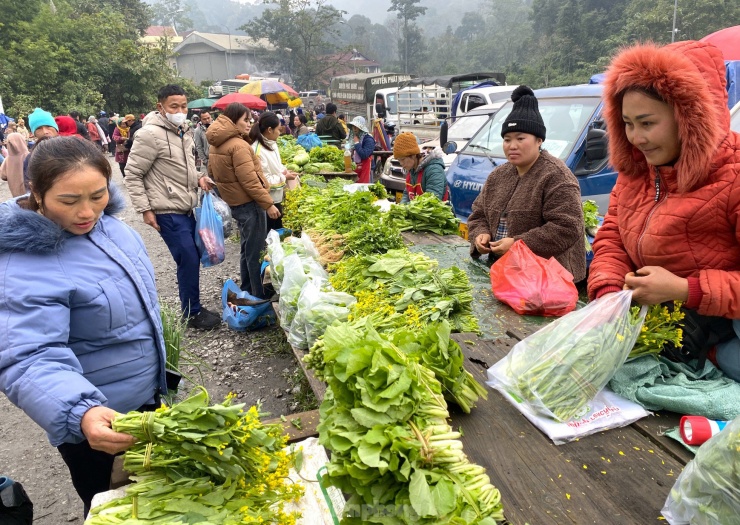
[249,111,298,231]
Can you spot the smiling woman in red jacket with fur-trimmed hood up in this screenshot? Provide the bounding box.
[588,42,740,381]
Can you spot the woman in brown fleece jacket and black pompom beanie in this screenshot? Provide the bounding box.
[468,86,586,282]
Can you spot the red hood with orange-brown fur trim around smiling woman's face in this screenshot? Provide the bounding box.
[604,41,730,192]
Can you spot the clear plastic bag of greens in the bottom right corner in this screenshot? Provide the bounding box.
[662,417,740,525]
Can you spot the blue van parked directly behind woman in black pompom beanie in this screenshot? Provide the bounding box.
[444,84,617,234]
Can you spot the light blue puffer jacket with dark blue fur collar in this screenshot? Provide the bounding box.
[0,186,166,446]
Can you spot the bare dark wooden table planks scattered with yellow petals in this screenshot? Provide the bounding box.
[451,334,685,525]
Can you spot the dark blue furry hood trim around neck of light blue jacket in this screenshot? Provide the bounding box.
[0,183,126,255]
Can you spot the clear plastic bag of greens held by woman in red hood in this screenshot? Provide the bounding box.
[504,290,647,422]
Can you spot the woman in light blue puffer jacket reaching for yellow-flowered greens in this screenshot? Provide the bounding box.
[0,137,166,514]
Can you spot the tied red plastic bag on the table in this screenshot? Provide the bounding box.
[491,240,578,317]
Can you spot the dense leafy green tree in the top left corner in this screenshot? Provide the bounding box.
[0,0,180,116]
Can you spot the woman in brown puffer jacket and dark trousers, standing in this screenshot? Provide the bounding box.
[206,102,280,299]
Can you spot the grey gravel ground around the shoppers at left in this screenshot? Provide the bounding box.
[0,158,314,525]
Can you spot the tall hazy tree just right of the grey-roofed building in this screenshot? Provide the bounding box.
[239,0,344,87]
